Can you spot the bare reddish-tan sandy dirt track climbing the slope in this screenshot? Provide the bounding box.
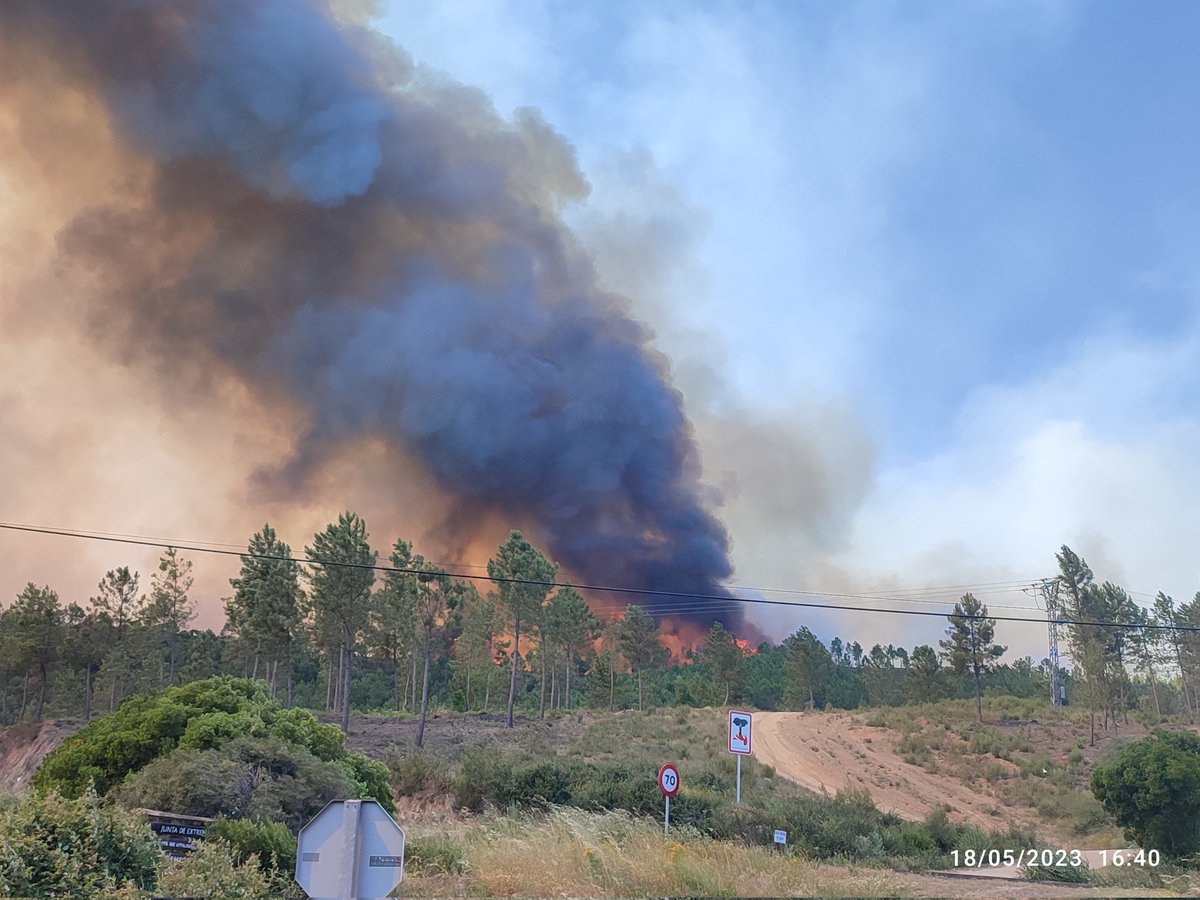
[754,713,1033,828]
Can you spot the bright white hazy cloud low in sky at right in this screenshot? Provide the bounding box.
[836,321,1200,653]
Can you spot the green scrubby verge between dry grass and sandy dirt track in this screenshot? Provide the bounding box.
[386,710,1037,870]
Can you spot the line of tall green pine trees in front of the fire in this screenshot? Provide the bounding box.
[0,525,1200,744]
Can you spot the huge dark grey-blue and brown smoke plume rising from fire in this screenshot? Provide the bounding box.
[0,0,731,620]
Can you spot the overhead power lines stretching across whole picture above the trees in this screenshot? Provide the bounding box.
[0,522,1200,631]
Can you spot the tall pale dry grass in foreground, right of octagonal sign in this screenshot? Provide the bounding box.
[395,809,905,898]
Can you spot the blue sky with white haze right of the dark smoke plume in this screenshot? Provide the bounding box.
[378,0,1200,654]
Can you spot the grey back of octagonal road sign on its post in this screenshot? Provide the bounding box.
[296,800,404,900]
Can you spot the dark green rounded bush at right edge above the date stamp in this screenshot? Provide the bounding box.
[1092,731,1200,858]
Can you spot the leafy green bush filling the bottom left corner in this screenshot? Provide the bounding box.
[0,793,163,900]
